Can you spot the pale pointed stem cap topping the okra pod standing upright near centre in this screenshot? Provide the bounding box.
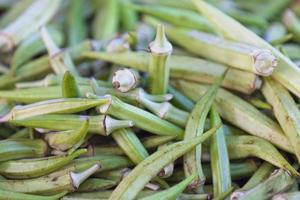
[149,24,173,54]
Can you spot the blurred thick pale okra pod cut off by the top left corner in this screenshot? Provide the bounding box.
[0,0,61,51]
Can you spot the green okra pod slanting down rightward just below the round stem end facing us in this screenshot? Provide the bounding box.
[92,94,183,137]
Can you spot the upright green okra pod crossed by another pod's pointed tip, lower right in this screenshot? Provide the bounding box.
[210,105,231,197]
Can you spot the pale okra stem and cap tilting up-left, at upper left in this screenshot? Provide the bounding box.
[40,27,79,76]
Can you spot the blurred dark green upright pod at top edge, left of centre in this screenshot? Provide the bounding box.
[67,0,87,45]
